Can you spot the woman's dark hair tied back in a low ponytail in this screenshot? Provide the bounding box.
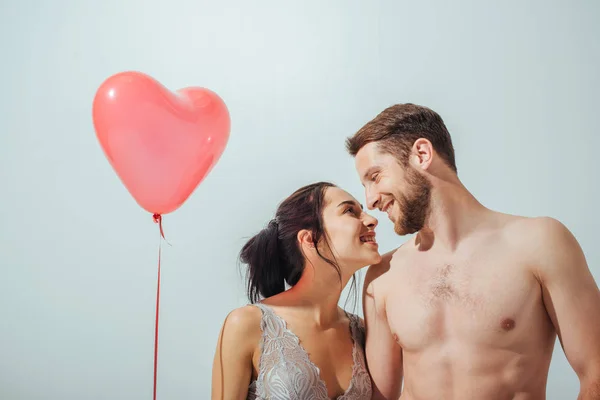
[240,182,357,303]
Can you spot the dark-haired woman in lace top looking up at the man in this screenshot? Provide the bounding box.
[212,182,381,400]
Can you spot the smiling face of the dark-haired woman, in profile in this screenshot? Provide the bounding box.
[319,187,381,274]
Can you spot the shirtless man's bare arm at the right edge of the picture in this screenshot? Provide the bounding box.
[533,218,600,400]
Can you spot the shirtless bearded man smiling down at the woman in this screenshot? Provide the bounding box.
[346,104,600,400]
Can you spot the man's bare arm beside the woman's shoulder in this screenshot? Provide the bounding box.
[363,254,402,400]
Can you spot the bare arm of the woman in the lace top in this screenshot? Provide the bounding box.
[211,306,261,400]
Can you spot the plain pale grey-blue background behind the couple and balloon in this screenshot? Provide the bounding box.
[0,0,600,400]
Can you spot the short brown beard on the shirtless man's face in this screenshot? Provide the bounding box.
[394,167,431,236]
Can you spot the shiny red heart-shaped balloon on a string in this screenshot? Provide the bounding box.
[93,72,231,214]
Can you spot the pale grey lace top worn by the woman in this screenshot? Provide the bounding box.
[247,303,371,400]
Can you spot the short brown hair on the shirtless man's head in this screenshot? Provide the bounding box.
[346,103,457,172]
